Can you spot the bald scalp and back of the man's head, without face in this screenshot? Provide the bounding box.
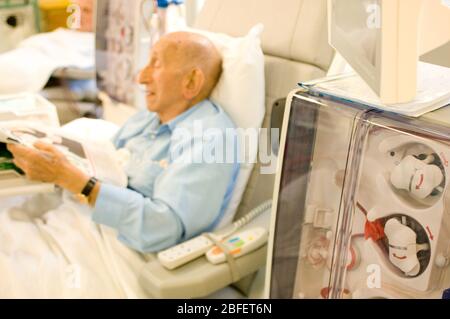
[160,32,222,100]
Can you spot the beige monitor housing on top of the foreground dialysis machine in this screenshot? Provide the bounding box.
[328,0,450,104]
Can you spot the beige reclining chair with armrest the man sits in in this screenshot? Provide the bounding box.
[137,0,334,298]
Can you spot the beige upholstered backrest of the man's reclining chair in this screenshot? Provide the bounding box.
[196,0,334,218]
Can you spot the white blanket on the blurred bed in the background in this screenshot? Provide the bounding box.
[0,29,95,94]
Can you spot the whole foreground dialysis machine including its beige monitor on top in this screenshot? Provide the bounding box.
[266,0,450,298]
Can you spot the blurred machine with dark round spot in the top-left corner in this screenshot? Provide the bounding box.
[0,0,40,53]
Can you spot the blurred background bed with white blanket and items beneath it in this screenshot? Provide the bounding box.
[0,29,97,124]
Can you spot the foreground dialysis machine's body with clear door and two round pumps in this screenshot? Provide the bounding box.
[266,90,450,298]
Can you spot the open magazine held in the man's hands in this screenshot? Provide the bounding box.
[0,122,128,187]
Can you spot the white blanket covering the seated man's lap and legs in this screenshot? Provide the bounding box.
[0,193,151,298]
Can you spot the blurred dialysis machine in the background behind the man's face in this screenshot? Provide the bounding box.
[96,0,157,109]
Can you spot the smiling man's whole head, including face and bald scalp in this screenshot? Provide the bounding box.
[139,32,222,123]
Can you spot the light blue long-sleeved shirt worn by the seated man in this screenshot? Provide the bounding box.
[92,100,239,253]
